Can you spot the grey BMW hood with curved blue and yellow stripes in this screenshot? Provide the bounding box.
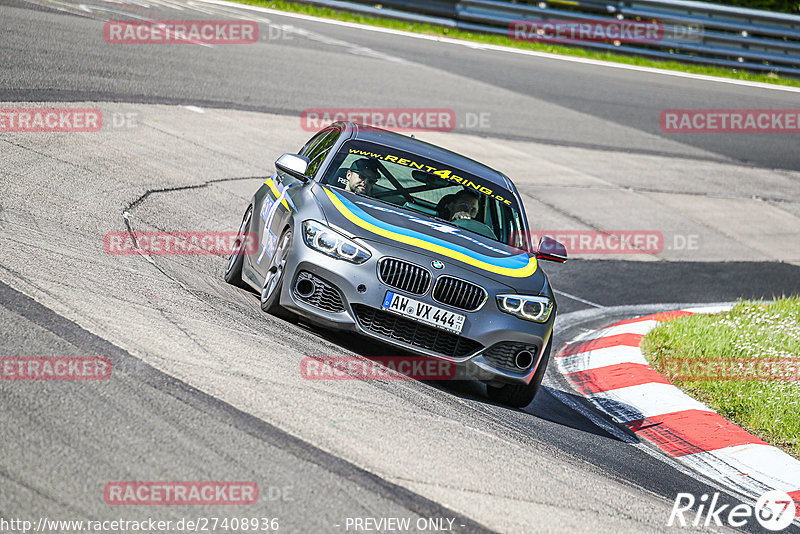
[314,186,545,291]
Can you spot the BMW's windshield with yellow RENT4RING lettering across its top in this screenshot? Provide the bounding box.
[322,141,528,251]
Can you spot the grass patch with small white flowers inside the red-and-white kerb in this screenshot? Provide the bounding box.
[642,296,800,458]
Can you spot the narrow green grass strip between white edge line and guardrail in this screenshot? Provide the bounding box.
[242,0,800,87]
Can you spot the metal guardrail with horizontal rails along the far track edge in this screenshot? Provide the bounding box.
[294,0,800,77]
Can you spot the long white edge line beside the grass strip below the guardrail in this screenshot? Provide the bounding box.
[195,0,800,93]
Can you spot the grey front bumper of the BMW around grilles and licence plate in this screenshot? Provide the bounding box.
[280,232,555,385]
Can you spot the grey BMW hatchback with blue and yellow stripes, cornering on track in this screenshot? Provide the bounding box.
[225,122,567,407]
